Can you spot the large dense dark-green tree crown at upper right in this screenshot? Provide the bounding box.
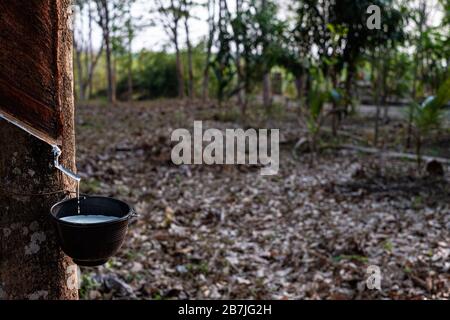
[281,0,404,111]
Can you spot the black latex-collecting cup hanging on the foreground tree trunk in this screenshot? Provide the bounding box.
[50,196,135,266]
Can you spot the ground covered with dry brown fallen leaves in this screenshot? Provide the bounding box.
[77,101,450,299]
